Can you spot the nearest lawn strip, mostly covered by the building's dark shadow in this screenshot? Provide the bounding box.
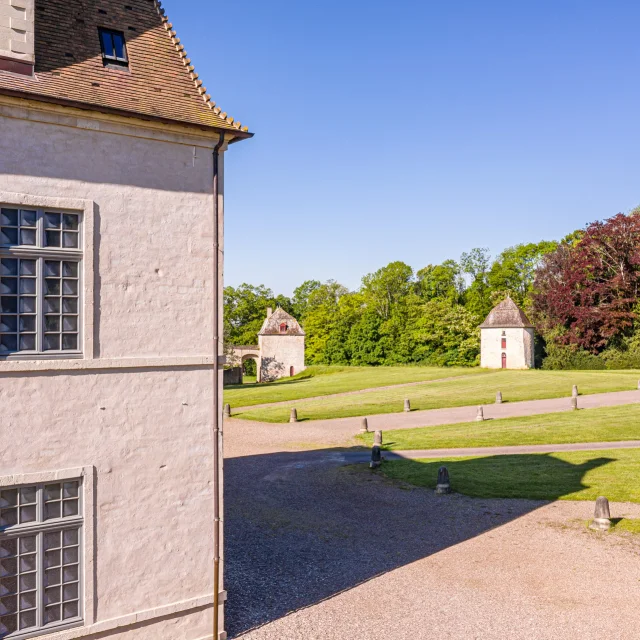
[380,449,640,502]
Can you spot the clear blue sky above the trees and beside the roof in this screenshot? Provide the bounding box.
[164,0,640,294]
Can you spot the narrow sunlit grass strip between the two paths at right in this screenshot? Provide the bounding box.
[358,404,640,450]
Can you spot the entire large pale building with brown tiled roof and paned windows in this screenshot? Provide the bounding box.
[0,0,251,640]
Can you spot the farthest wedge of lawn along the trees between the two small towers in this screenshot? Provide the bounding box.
[224,366,487,407]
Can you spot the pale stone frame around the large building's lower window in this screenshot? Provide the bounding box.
[0,465,96,640]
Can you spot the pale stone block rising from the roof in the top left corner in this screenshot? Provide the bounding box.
[0,0,35,64]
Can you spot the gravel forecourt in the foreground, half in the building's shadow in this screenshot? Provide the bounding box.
[225,444,640,640]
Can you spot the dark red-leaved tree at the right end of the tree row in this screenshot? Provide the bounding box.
[533,213,640,353]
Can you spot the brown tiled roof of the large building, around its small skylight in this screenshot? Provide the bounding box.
[0,0,251,137]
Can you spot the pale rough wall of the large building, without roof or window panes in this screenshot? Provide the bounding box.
[0,96,230,640]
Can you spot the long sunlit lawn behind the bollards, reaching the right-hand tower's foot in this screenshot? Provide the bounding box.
[234,367,640,422]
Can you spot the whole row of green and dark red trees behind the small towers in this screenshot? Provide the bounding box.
[225,210,640,369]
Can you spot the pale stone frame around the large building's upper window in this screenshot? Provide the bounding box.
[0,191,95,364]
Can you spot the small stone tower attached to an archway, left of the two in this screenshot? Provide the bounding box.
[258,307,306,382]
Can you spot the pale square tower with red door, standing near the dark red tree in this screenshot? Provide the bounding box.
[480,297,534,369]
